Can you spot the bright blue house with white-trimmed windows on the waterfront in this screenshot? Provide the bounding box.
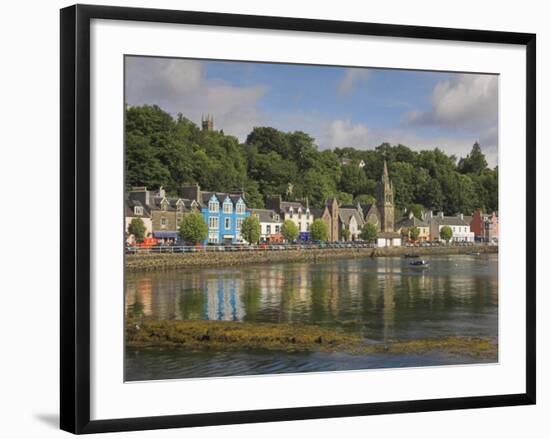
[181,184,250,244]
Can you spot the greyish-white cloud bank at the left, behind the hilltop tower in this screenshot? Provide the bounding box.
[126,57,267,140]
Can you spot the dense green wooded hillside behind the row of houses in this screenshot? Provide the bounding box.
[126,106,498,215]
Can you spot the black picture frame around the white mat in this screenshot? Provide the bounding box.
[60,5,536,434]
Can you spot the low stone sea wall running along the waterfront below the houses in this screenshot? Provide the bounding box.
[126,245,498,271]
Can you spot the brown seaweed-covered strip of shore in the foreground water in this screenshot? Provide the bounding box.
[126,320,498,358]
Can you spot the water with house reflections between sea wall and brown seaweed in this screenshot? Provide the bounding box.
[125,255,498,341]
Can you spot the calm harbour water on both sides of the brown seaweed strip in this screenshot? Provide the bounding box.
[125,254,498,381]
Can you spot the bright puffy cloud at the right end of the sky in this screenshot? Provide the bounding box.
[406,74,498,128]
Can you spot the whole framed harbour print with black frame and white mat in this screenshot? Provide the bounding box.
[61,5,536,433]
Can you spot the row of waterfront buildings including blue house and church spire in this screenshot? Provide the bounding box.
[125,163,498,247]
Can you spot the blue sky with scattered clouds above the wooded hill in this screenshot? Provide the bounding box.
[125,56,498,167]
